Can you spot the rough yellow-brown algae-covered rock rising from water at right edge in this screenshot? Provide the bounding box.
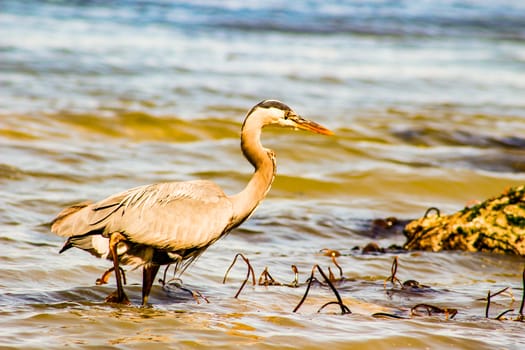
[403,186,525,256]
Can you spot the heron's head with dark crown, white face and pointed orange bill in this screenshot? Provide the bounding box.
[248,100,333,135]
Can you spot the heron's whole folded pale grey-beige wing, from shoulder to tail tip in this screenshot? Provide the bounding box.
[51,181,233,251]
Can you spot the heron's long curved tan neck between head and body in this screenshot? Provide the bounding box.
[230,114,276,224]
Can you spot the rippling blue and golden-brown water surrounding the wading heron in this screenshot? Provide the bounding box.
[0,1,525,349]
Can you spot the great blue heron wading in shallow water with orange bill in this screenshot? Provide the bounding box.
[51,100,332,305]
